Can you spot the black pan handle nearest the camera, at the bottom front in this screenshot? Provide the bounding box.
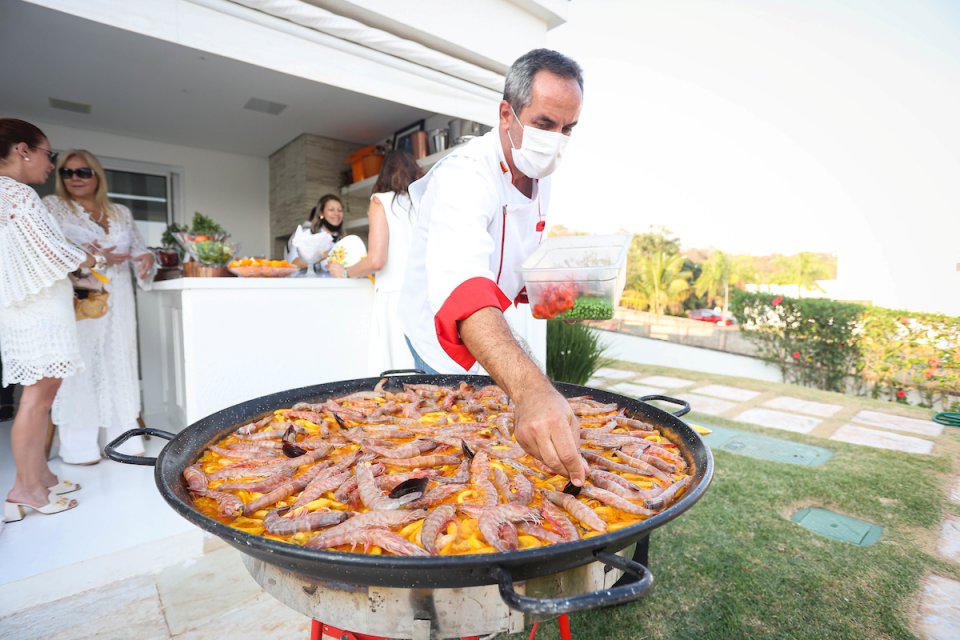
[491,551,653,617]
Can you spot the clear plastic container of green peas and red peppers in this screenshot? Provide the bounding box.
[520,234,630,320]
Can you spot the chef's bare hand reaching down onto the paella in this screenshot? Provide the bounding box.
[514,385,587,487]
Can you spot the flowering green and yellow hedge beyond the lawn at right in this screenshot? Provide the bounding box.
[731,291,960,407]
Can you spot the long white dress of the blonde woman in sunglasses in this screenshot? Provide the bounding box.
[43,196,152,463]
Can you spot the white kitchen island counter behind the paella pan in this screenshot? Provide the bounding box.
[137,278,546,432]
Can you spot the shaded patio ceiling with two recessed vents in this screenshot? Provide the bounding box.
[0,1,430,157]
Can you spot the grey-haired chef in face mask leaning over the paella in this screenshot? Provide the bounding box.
[400,49,586,485]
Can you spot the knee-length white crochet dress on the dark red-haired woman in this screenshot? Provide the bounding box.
[0,176,86,386]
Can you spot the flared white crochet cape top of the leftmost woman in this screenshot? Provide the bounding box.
[0,176,86,307]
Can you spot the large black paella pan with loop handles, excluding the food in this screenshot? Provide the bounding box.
[105,375,713,613]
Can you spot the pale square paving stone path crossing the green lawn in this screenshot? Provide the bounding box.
[587,367,960,640]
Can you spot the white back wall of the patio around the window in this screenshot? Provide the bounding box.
[29,119,270,255]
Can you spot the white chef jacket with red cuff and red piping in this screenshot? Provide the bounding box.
[400,129,550,373]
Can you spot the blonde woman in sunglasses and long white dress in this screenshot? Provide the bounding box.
[43,149,154,464]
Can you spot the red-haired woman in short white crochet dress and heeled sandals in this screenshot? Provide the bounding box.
[0,118,103,522]
